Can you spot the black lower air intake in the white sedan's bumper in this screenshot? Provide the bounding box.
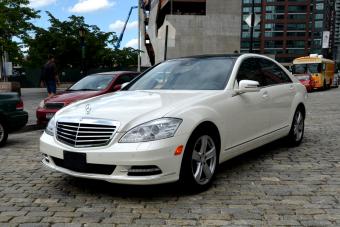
[52,157,116,175]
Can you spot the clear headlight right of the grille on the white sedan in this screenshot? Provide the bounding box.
[119,118,182,143]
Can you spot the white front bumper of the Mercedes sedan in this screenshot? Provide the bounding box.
[40,133,189,185]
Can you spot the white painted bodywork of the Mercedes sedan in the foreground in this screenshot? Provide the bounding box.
[40,54,307,184]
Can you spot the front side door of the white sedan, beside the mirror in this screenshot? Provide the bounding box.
[226,58,269,150]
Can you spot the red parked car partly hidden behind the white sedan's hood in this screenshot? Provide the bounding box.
[36,71,139,125]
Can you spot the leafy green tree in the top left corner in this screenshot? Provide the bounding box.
[0,0,39,61]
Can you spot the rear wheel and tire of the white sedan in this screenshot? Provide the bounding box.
[287,108,305,147]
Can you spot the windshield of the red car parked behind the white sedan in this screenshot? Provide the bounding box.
[68,74,114,91]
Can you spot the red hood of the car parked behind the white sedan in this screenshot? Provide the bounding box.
[45,91,101,104]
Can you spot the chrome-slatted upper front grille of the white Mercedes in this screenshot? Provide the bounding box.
[56,119,117,147]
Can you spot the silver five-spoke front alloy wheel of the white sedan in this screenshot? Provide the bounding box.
[191,135,217,185]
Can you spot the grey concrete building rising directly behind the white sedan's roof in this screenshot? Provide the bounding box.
[141,0,242,66]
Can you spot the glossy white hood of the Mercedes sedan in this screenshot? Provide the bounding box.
[56,91,216,131]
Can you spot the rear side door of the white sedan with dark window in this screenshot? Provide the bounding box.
[260,59,296,132]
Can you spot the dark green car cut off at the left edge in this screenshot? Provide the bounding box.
[0,92,28,147]
